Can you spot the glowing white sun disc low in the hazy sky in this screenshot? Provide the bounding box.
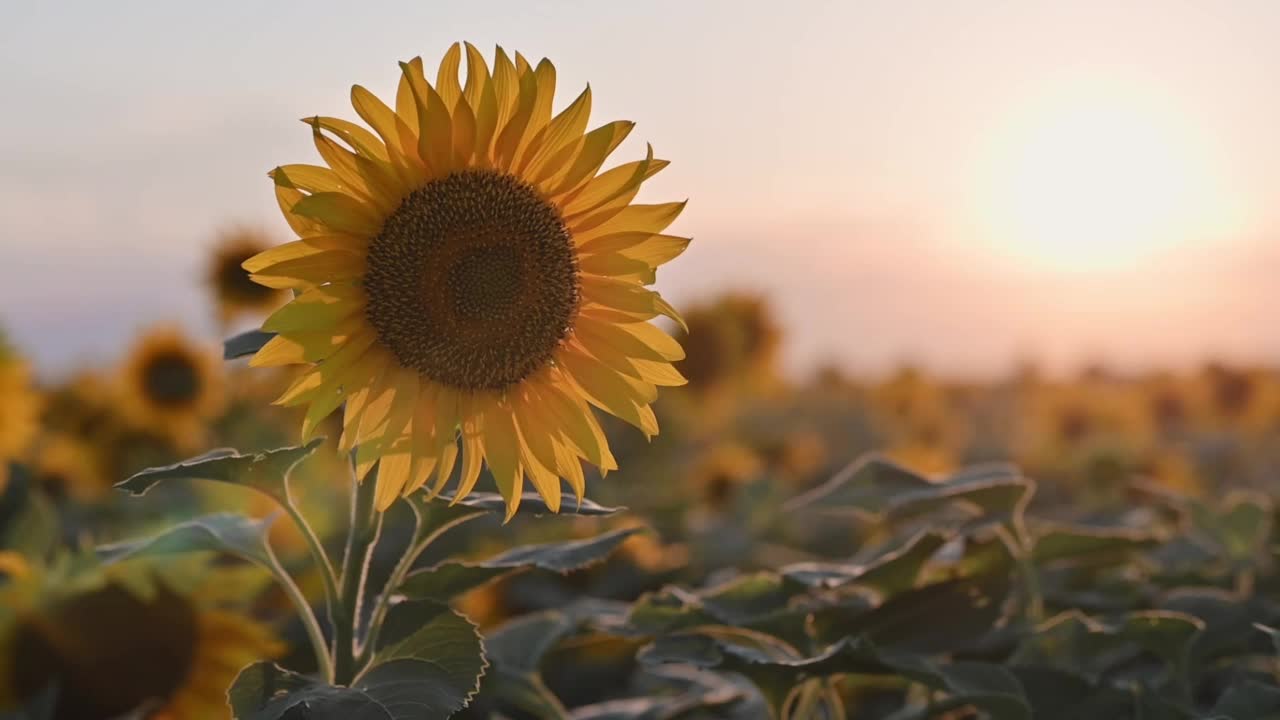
[977,83,1230,272]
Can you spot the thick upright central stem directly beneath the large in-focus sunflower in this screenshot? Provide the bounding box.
[333,458,381,685]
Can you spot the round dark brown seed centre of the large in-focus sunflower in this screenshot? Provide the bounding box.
[364,170,579,389]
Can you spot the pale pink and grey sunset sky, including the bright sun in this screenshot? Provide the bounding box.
[0,0,1280,375]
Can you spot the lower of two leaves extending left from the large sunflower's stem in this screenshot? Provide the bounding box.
[97,512,275,569]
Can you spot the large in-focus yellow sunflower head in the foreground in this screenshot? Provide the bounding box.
[244,45,689,512]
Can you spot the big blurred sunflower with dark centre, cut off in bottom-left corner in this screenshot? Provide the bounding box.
[0,561,283,720]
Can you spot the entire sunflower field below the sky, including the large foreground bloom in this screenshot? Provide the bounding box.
[0,44,1280,720]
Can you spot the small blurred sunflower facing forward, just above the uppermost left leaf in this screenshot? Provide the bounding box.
[119,328,224,448]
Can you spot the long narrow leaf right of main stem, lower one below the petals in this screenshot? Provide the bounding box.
[398,528,641,602]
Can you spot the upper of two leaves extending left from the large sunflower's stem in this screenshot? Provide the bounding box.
[115,438,324,505]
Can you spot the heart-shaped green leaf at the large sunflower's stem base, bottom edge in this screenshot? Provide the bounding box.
[227,660,483,720]
